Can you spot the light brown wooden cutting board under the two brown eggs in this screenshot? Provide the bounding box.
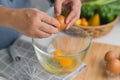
[74,43,120,80]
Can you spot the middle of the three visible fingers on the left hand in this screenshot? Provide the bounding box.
[39,22,58,34]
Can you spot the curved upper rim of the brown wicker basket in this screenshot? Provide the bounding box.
[79,16,119,29]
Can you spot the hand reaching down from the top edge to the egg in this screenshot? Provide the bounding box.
[55,0,81,29]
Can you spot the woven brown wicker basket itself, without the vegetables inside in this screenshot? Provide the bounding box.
[79,17,119,38]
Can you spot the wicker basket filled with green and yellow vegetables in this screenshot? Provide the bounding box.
[77,0,120,38]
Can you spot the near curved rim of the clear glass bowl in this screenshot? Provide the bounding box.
[32,31,92,58]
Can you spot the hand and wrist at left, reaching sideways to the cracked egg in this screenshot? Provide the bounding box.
[9,8,60,38]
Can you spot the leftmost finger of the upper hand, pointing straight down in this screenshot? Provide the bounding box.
[54,0,63,16]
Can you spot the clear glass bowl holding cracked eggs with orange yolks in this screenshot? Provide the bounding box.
[32,26,92,74]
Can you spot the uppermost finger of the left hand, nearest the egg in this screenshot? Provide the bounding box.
[42,14,60,27]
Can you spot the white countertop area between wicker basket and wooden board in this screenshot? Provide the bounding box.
[93,21,120,46]
